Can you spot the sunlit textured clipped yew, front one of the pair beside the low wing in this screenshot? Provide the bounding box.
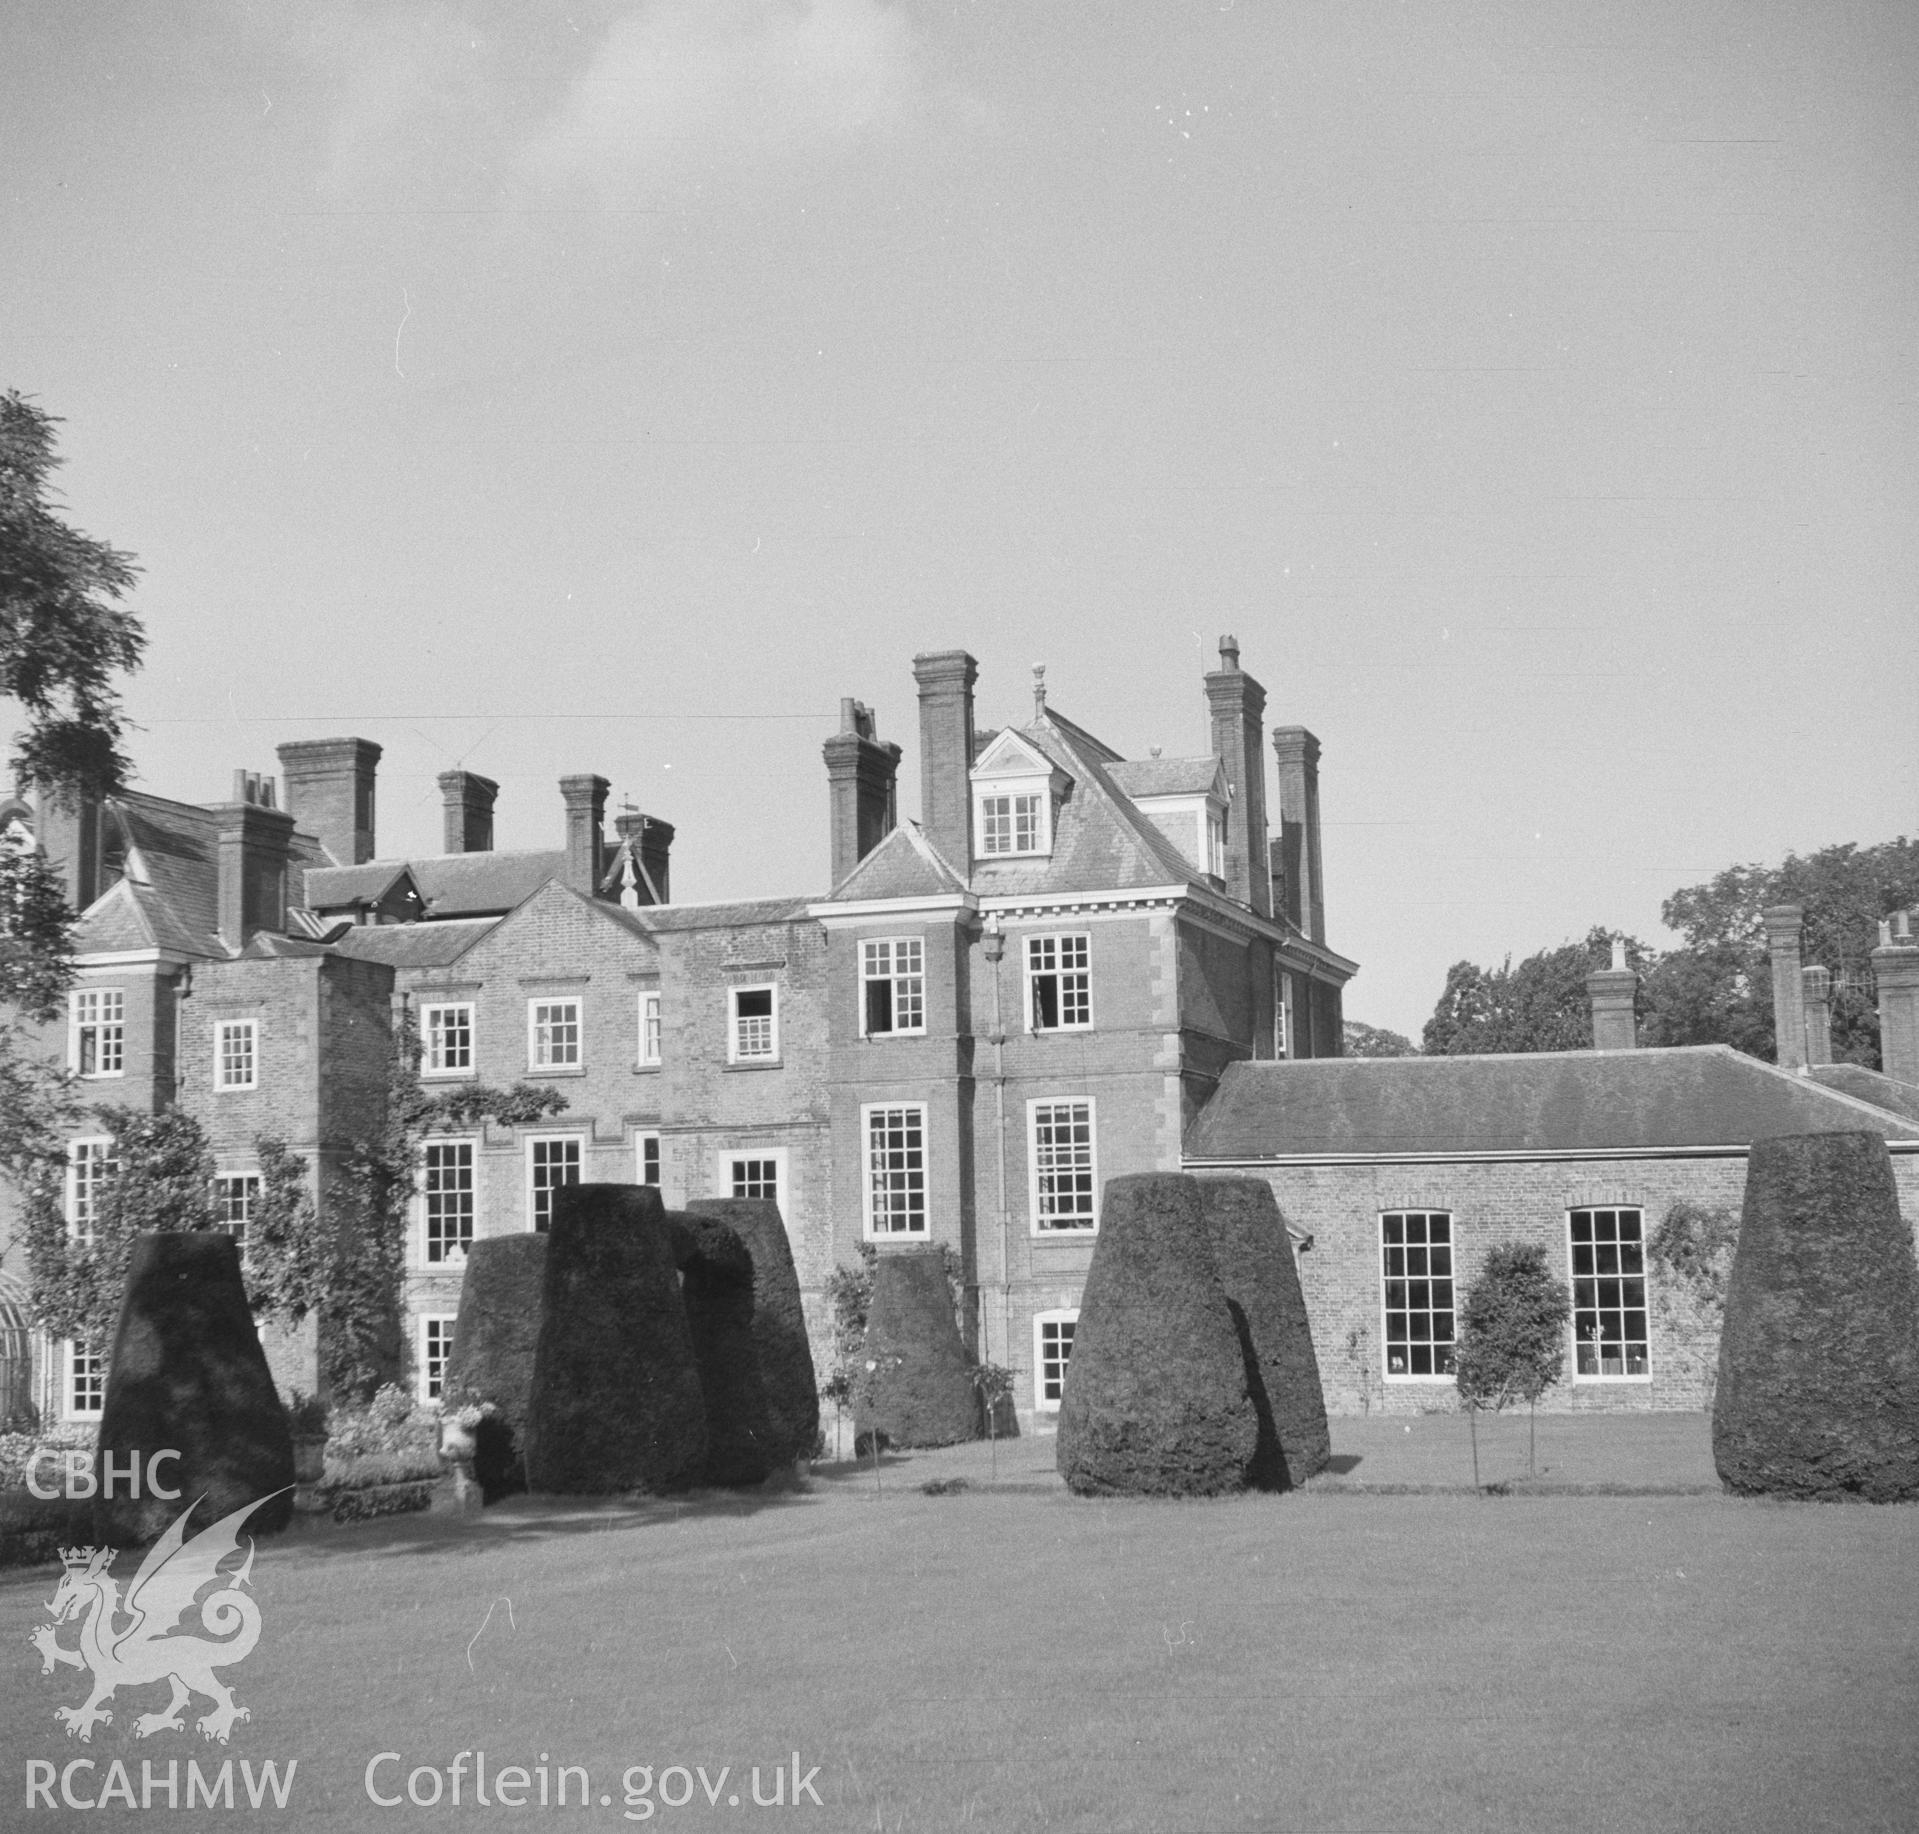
[1057,1172,1259,1496]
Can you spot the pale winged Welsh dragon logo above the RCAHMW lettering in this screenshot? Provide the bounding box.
[33,1493,278,1744]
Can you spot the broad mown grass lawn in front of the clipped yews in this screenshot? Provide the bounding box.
[0,1433,1919,1834]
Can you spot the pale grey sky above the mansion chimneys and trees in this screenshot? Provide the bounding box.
[0,0,1919,1036]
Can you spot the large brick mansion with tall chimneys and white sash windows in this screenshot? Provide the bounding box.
[0,637,1919,1429]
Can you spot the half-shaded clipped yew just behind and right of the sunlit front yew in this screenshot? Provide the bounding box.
[1199,1178,1332,1491]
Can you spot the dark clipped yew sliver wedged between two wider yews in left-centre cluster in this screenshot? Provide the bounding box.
[666,1211,773,1489]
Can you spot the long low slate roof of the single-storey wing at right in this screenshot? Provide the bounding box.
[1186,1044,1919,1161]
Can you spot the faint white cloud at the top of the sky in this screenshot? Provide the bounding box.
[526,0,923,192]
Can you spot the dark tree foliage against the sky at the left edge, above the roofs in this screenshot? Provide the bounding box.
[0,389,146,796]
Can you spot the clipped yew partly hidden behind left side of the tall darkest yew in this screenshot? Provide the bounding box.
[445,1234,547,1502]
